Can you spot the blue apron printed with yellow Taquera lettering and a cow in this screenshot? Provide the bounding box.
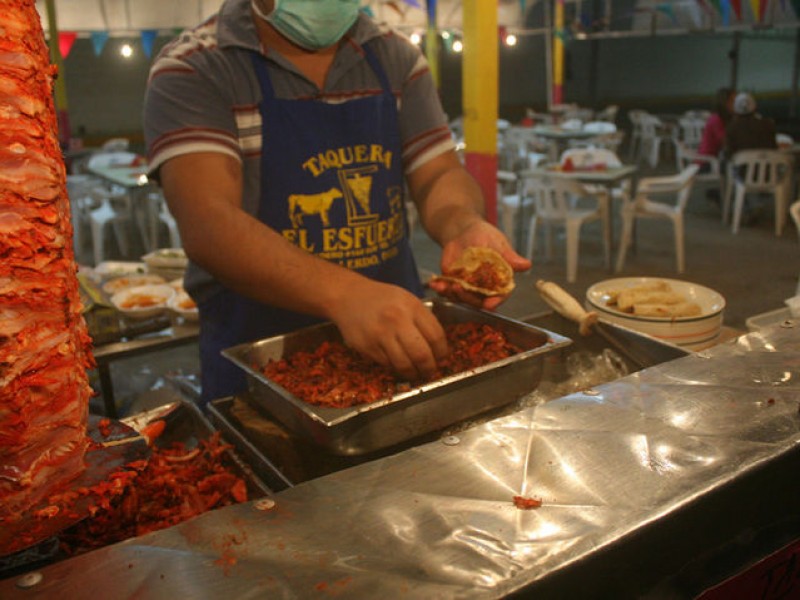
[199,46,423,402]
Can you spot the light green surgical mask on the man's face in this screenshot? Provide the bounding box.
[251,0,360,50]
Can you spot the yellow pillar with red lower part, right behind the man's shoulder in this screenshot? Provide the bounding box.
[462,0,499,223]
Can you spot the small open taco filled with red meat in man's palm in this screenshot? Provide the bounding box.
[432,246,515,296]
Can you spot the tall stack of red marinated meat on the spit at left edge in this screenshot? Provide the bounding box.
[0,0,94,526]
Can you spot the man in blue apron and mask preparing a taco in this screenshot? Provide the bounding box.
[144,0,531,402]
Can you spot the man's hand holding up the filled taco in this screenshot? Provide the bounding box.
[429,221,531,310]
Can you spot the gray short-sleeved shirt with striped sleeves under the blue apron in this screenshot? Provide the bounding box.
[144,0,454,297]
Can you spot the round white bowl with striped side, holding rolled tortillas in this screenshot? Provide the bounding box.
[586,277,725,350]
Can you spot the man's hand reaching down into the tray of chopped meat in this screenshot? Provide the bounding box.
[329,278,448,381]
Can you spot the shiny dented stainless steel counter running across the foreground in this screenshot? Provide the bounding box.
[0,322,800,600]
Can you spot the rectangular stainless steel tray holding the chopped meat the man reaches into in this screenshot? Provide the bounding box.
[222,300,572,456]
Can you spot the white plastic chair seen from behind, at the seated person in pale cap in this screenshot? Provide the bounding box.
[722,150,793,235]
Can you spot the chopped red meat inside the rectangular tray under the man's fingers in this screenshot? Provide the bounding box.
[261,322,522,408]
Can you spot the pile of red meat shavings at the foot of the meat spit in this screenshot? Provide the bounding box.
[61,432,247,555]
